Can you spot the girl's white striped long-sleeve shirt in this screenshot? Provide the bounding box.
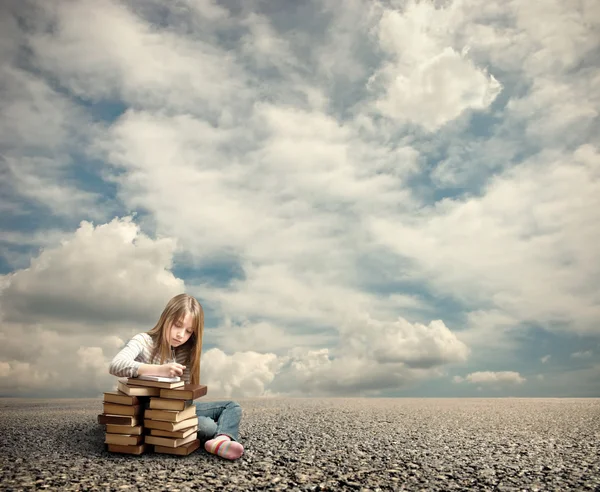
[108,333,190,383]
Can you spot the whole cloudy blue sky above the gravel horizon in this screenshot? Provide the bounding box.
[0,0,600,399]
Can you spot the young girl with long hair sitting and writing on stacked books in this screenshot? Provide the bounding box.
[108,294,244,460]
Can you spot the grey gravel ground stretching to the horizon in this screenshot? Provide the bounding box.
[0,399,600,491]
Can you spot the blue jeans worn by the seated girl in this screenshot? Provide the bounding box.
[194,400,242,442]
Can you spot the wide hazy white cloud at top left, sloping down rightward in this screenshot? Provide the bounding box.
[29,0,244,114]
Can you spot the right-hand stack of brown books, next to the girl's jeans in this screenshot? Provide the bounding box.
[143,383,207,456]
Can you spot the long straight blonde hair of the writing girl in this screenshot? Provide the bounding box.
[147,294,204,384]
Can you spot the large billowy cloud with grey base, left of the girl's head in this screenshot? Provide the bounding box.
[0,217,184,326]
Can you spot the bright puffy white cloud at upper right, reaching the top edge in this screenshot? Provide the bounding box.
[371,1,502,131]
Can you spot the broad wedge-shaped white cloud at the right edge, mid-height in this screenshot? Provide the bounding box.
[370,145,600,333]
